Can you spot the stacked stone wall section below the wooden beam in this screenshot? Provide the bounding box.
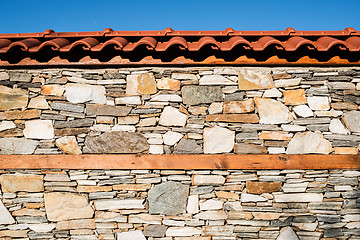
[0,170,360,240]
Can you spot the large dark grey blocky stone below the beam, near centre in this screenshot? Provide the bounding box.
[148,181,189,215]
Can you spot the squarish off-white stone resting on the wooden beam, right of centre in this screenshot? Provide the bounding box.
[204,126,235,153]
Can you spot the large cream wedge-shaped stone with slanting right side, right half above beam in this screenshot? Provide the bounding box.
[255,98,293,124]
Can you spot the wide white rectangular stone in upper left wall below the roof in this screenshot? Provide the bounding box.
[65,83,106,104]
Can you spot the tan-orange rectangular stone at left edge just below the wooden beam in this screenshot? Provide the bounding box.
[0,174,44,193]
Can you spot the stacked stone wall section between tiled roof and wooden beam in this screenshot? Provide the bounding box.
[0,67,360,154]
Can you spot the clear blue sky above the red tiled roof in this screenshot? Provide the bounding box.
[0,0,360,33]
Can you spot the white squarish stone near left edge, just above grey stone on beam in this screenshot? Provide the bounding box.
[24,120,55,139]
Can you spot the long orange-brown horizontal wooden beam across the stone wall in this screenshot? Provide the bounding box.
[0,154,360,169]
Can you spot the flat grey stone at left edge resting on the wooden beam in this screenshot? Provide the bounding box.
[0,138,39,154]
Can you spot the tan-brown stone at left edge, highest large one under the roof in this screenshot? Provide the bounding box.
[0,85,28,111]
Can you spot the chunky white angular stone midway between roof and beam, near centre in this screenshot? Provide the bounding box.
[159,106,188,127]
